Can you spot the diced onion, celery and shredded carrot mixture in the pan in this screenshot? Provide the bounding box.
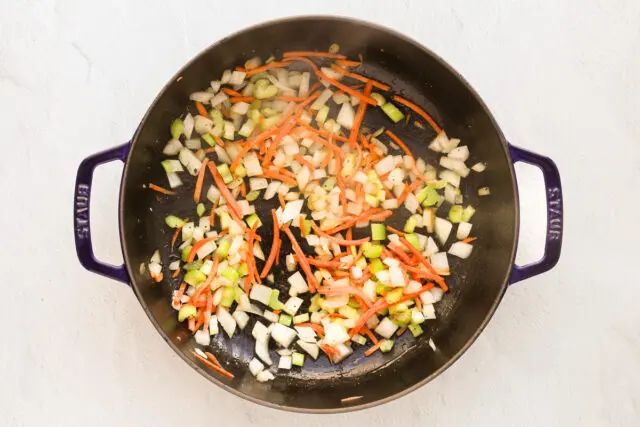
[141,45,490,382]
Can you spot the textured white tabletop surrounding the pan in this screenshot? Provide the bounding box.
[0,0,640,427]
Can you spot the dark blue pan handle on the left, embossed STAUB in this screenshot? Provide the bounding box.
[73,143,131,284]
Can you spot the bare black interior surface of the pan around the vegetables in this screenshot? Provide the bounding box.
[120,17,518,412]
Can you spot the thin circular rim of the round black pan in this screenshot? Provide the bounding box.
[118,15,520,414]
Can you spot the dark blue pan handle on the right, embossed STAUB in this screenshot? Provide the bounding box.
[509,144,564,284]
